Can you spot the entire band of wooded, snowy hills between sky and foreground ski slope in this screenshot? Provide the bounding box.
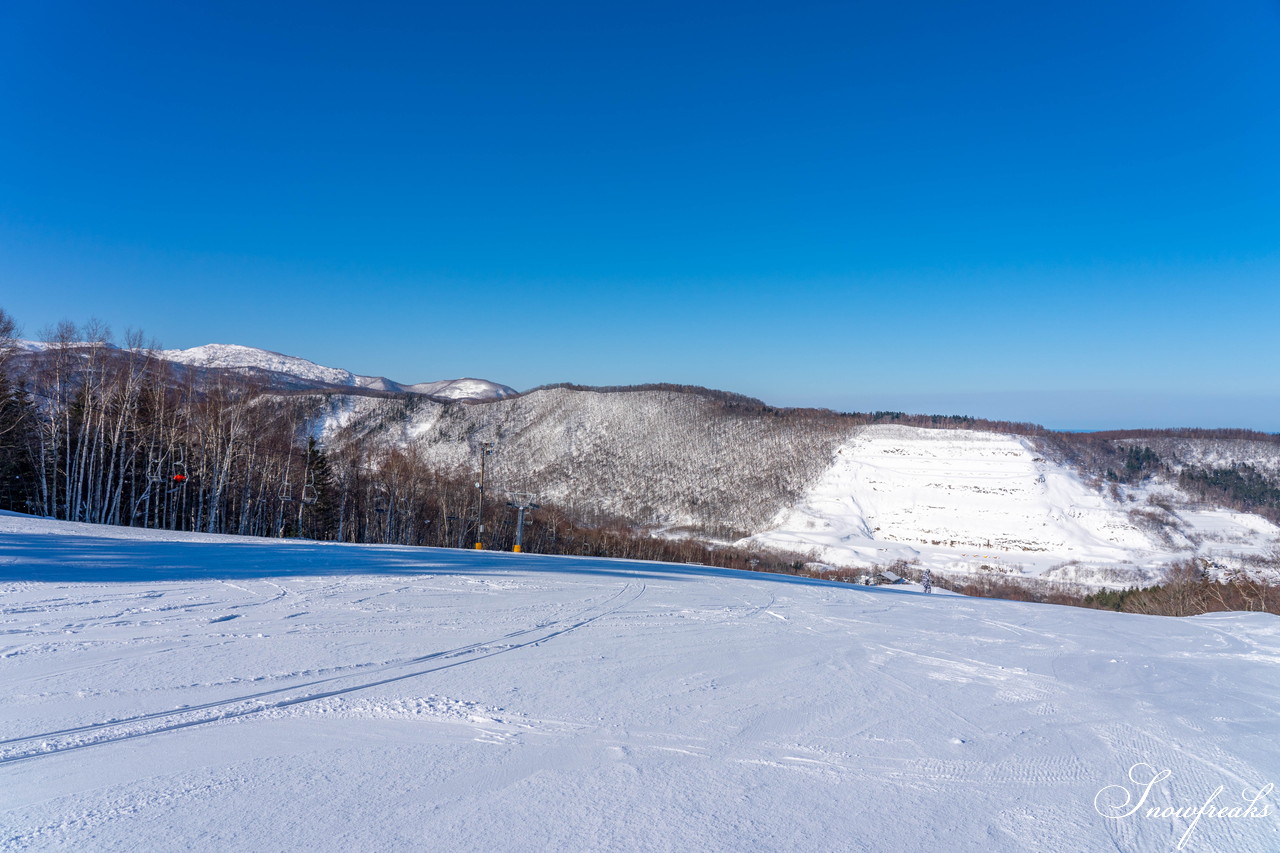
[0,313,1280,578]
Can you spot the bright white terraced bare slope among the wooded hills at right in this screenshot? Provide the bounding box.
[749,425,1280,585]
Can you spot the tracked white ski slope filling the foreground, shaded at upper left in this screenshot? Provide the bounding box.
[0,515,1280,853]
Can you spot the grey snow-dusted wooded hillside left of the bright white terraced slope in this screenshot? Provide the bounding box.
[314,388,856,538]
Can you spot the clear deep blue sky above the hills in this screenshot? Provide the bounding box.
[0,0,1280,430]
